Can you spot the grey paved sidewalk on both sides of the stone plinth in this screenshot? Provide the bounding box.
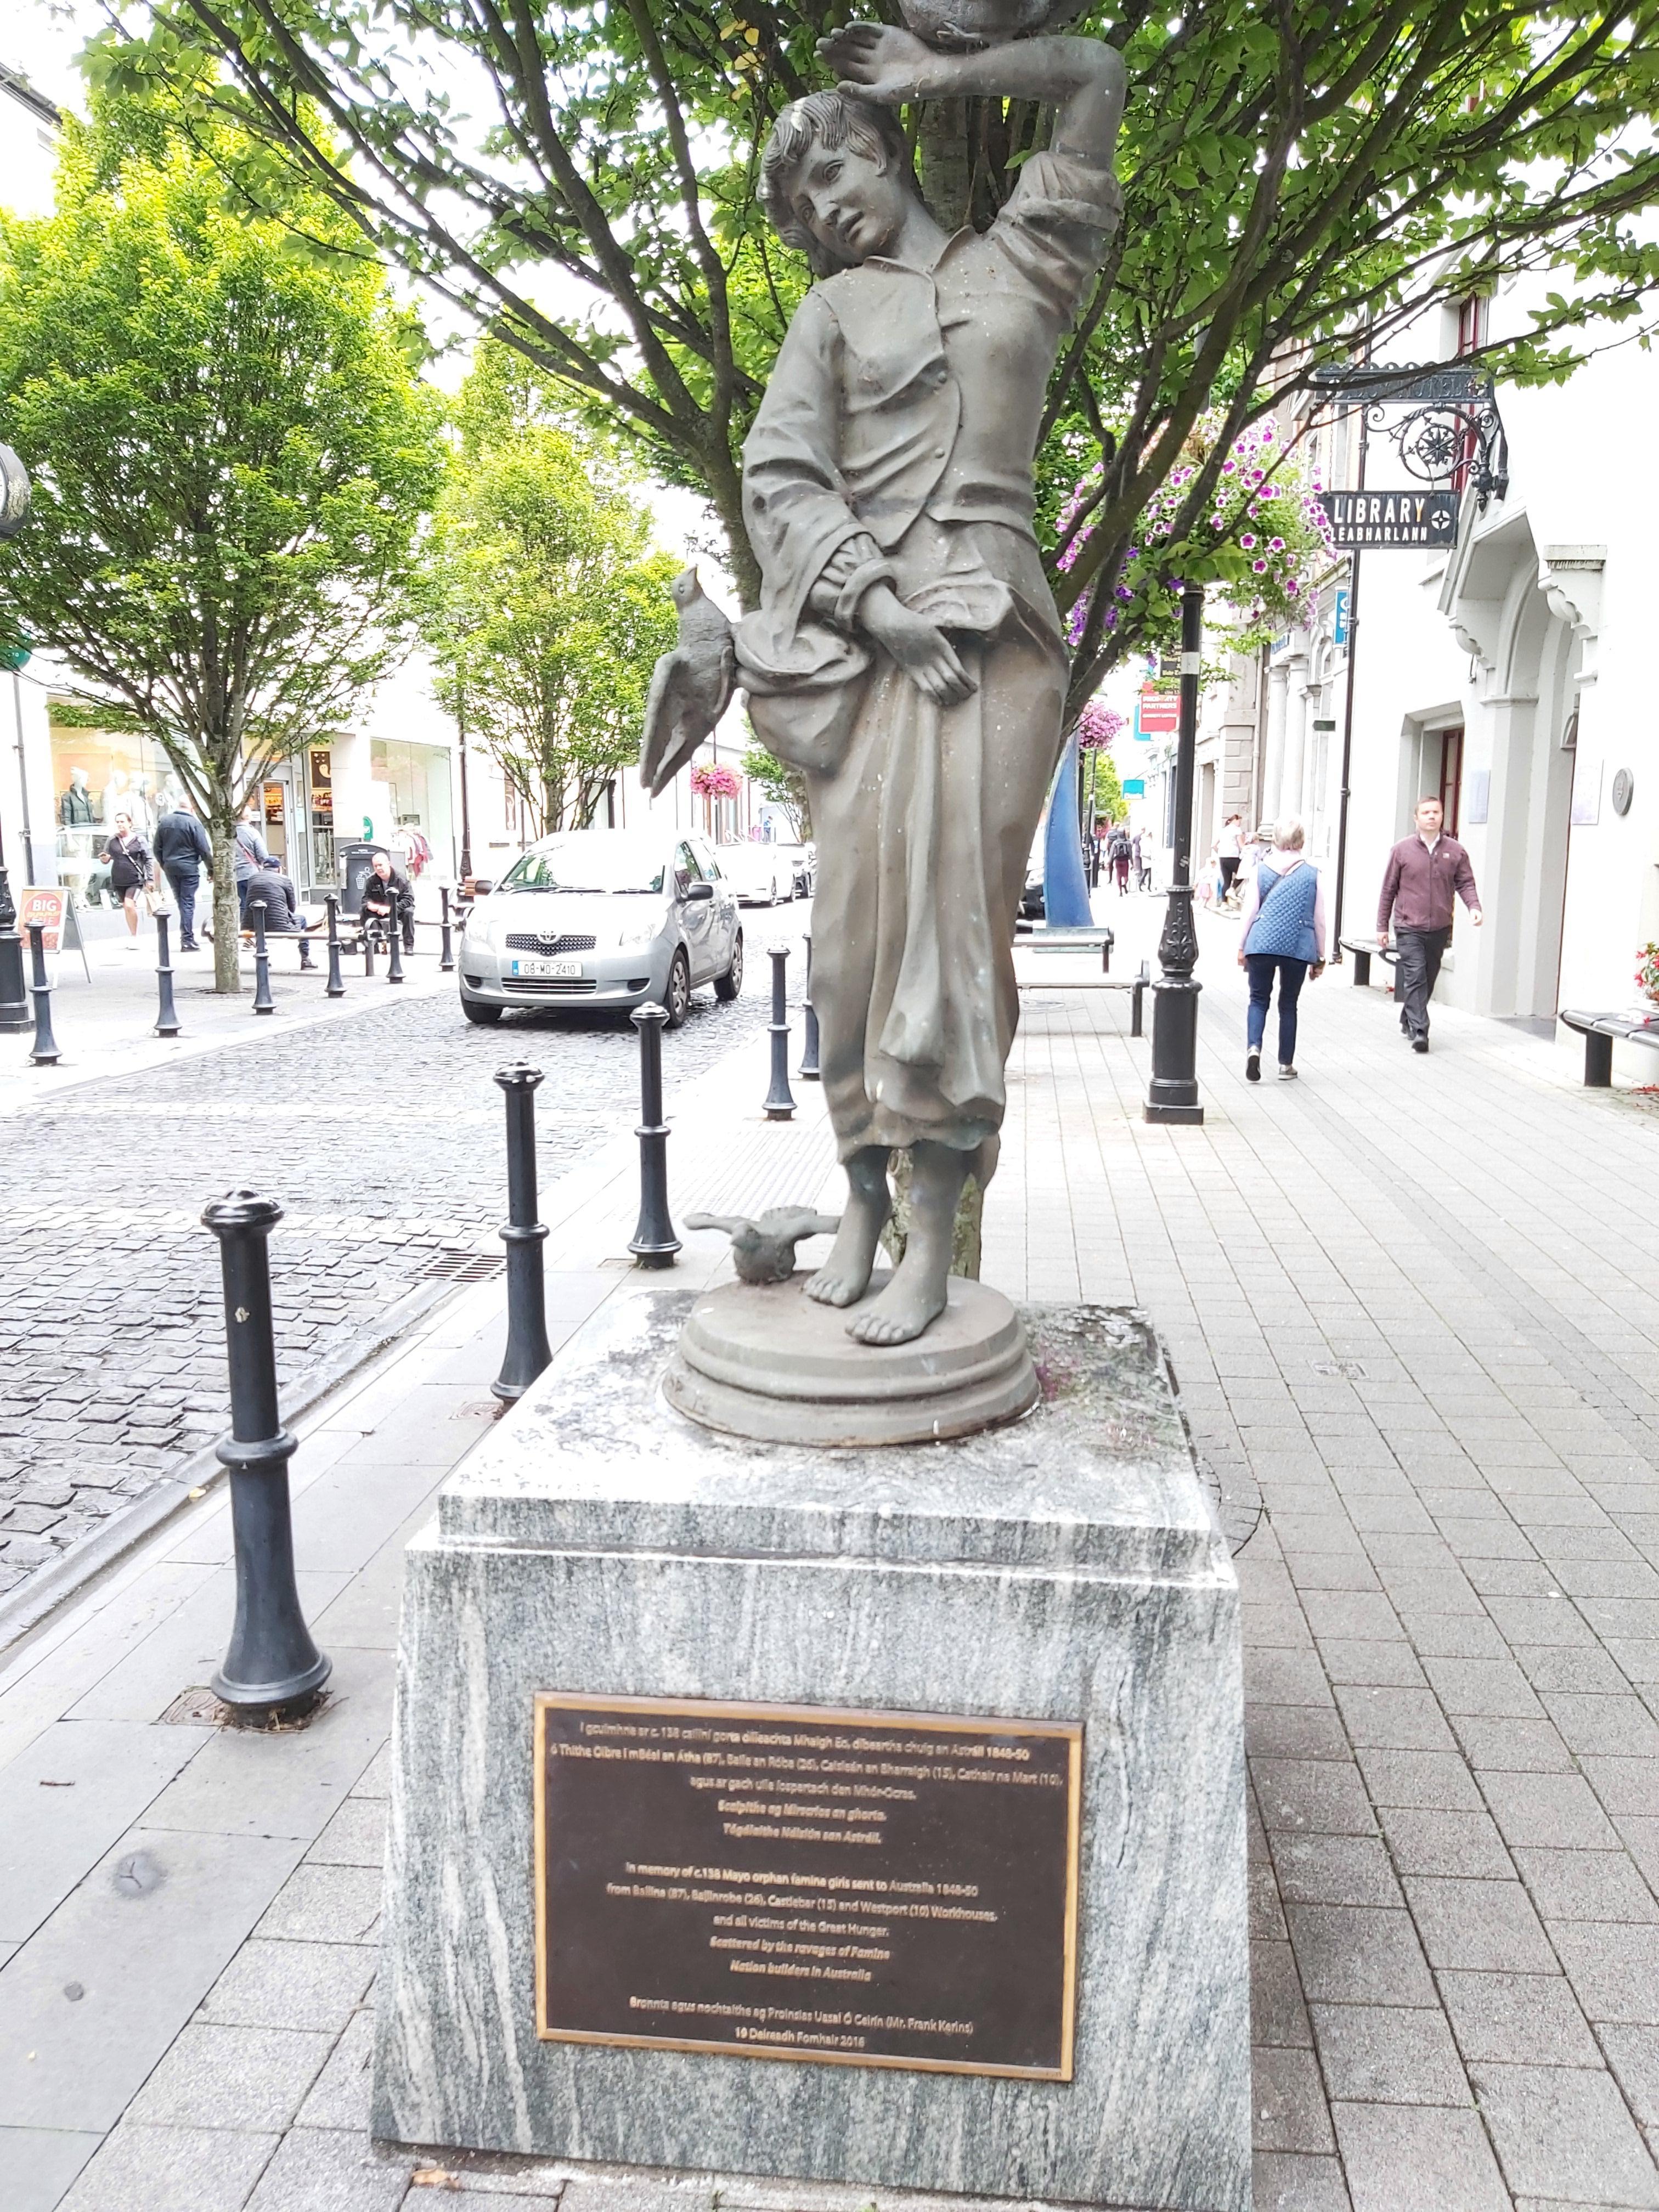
[0,900,1659,2212]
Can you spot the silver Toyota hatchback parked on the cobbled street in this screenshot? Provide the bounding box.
[458,830,743,1029]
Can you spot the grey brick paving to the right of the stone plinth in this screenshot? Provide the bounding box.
[984,900,1659,2212]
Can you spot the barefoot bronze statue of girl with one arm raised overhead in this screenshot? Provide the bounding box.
[737,24,1124,1345]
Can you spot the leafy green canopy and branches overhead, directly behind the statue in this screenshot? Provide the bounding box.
[95,0,1659,706]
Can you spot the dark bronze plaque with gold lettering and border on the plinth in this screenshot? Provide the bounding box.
[535,1695,1084,2081]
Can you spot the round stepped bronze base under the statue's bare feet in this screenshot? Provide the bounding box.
[664,1269,1037,1444]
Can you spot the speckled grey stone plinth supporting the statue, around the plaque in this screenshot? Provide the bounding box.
[374,1292,1250,2212]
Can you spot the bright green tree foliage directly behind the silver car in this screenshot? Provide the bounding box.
[418,341,679,836]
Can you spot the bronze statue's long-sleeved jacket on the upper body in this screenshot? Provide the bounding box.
[737,153,1121,772]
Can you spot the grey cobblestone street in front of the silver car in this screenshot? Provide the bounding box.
[0,905,812,1595]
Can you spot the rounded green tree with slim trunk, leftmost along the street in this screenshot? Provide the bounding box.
[0,111,440,991]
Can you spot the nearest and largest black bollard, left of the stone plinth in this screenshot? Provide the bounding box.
[201,1190,330,1721]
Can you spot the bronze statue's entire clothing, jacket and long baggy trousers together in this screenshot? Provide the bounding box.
[737,153,1121,1181]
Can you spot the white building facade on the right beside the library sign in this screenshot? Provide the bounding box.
[1150,287,1659,1082]
